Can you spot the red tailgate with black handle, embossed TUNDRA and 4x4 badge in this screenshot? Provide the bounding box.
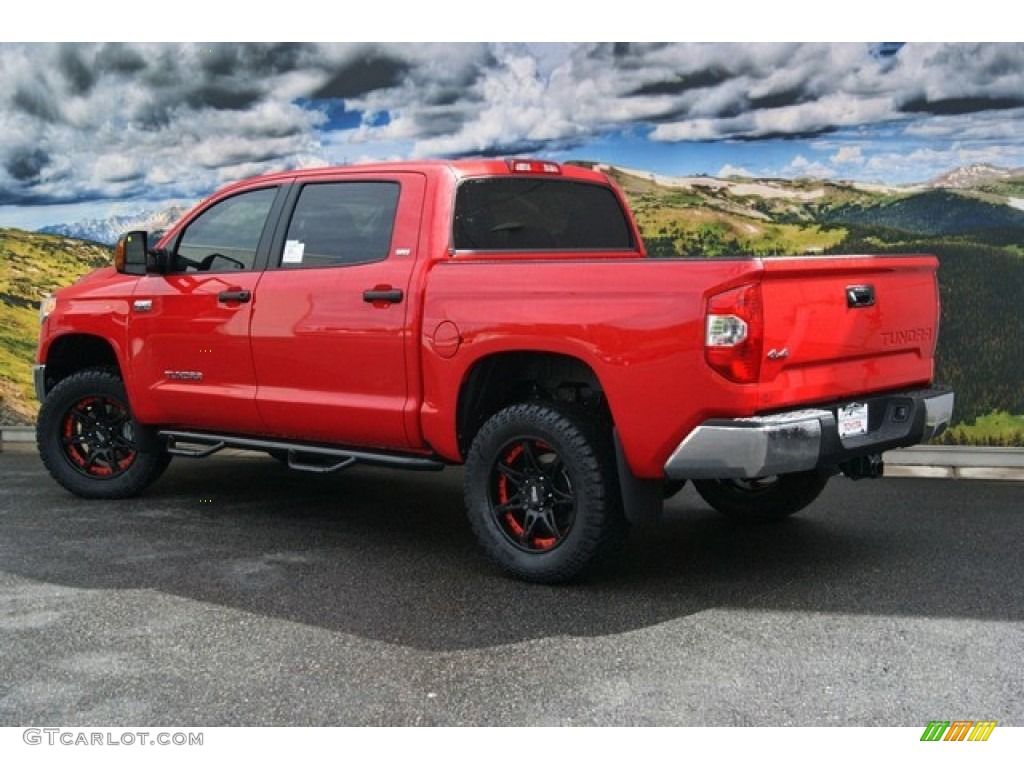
[759,255,939,409]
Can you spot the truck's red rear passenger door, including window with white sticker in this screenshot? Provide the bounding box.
[251,173,425,449]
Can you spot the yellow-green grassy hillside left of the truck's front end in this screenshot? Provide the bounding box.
[0,229,111,424]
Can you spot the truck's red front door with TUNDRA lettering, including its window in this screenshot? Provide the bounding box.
[128,185,287,432]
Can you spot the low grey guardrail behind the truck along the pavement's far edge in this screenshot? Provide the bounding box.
[0,427,1024,480]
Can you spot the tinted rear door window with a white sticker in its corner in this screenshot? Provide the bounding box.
[281,181,400,269]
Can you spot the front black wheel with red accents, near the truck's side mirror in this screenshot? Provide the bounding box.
[36,369,170,499]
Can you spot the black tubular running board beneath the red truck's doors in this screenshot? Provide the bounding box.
[159,429,444,474]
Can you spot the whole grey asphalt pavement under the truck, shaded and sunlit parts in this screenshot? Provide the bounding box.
[0,449,1024,728]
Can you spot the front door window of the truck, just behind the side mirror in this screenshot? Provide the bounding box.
[173,187,278,272]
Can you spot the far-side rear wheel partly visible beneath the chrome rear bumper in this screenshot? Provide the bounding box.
[693,470,830,522]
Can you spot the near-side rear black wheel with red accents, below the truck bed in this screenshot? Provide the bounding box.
[465,402,627,584]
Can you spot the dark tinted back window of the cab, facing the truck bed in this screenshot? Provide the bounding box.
[454,178,634,251]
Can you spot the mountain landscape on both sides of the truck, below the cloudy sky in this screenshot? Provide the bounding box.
[0,162,1024,444]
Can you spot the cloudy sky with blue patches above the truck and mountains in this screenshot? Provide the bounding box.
[0,43,1024,228]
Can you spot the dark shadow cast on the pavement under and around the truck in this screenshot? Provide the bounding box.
[0,454,1024,650]
